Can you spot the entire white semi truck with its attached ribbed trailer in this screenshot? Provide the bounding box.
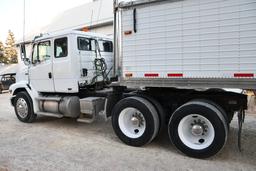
[10,0,256,158]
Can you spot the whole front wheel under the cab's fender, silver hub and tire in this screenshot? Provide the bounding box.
[14,91,36,123]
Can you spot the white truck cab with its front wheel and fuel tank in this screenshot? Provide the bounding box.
[10,31,113,122]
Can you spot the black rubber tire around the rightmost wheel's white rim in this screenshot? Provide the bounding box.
[168,101,228,158]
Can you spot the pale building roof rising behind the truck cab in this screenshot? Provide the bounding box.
[43,0,114,35]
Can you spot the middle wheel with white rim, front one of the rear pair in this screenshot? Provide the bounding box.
[112,97,159,146]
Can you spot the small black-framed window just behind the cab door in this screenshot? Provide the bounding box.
[54,37,68,58]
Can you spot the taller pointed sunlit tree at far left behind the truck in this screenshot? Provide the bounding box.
[4,30,18,63]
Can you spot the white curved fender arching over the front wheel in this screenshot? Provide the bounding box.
[9,80,39,113]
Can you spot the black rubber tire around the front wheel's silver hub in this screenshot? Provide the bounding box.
[14,91,37,123]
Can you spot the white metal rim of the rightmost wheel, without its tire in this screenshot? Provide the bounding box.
[178,114,215,150]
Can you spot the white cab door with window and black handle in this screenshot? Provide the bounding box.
[29,40,55,92]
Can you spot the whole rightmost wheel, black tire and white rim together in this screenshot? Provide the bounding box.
[168,101,228,158]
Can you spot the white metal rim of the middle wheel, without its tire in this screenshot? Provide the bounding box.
[118,107,146,138]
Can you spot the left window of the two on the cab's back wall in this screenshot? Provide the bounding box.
[77,37,96,51]
